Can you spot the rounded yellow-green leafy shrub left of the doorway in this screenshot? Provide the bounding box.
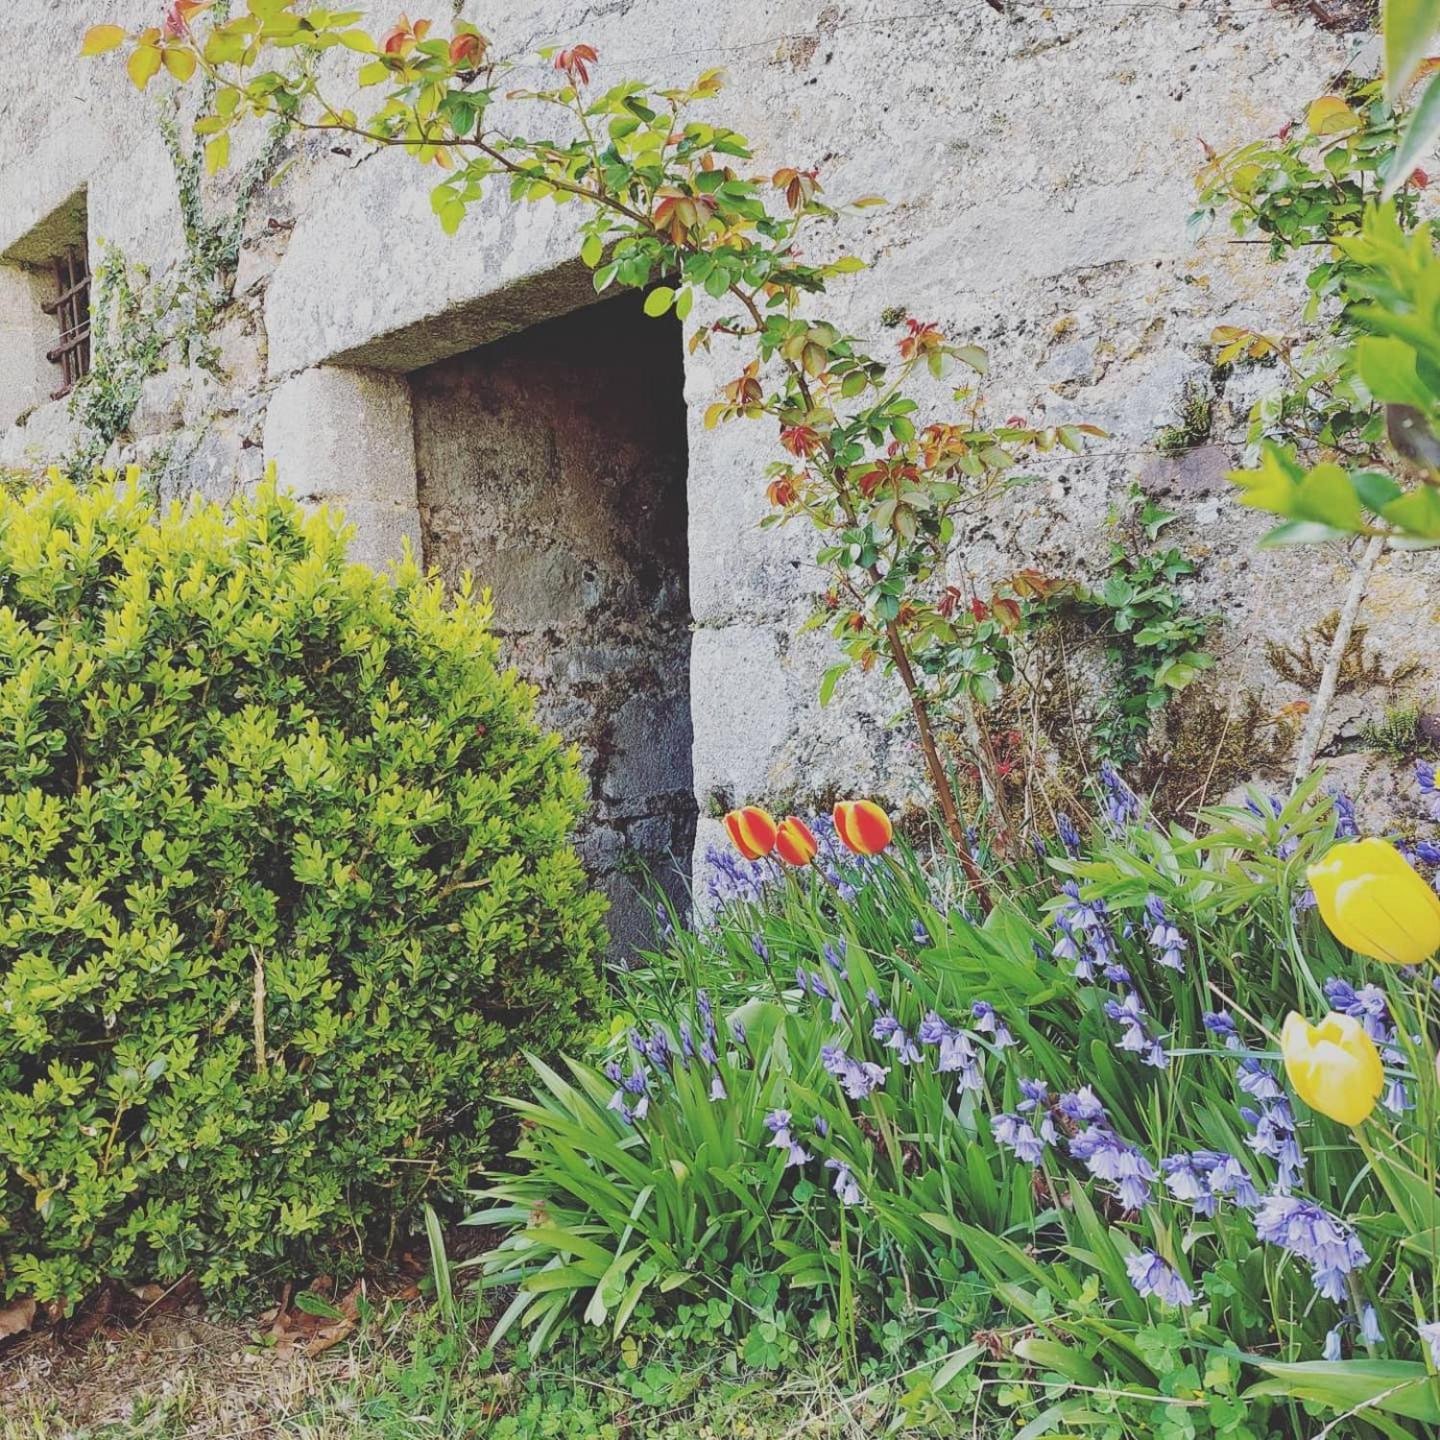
[0,482,602,1305]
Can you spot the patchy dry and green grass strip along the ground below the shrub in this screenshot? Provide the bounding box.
[0,1296,989,1440]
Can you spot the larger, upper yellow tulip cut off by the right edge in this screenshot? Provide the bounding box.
[1306,840,1440,965]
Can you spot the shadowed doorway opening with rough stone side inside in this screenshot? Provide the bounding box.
[410,295,696,949]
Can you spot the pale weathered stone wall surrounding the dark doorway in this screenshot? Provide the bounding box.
[0,0,1437,933]
